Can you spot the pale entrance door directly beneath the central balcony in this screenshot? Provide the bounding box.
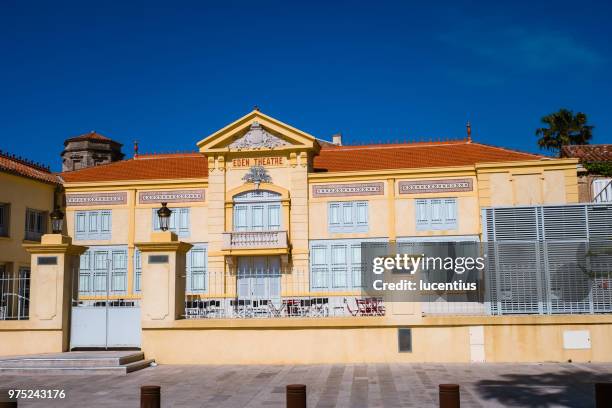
[238,256,280,303]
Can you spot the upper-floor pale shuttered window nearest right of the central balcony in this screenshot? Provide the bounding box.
[327,201,368,233]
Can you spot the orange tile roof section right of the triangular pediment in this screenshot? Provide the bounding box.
[314,140,545,172]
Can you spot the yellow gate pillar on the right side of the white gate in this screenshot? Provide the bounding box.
[135,231,193,322]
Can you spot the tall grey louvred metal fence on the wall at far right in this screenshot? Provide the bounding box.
[483,204,612,314]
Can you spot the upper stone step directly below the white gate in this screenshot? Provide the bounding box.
[0,351,144,368]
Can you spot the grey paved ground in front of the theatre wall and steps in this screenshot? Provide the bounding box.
[0,364,612,408]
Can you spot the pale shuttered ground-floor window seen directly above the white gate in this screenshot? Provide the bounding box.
[79,246,127,296]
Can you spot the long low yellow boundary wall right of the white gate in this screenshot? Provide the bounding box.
[143,315,612,364]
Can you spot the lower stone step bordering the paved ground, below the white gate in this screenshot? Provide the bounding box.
[0,359,155,376]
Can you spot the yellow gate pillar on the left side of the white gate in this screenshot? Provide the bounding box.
[23,234,87,351]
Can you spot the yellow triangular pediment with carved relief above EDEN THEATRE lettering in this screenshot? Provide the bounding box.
[198,110,319,153]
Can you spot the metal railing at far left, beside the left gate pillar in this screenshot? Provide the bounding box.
[0,269,30,320]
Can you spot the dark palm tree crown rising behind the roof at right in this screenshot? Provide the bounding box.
[536,109,593,155]
